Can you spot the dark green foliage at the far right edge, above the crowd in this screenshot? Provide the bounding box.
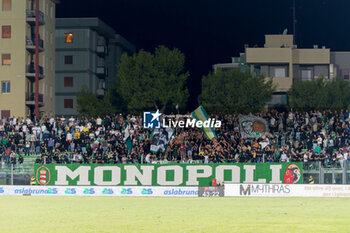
[289,78,350,111]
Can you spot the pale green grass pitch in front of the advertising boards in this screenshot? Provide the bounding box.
[0,196,350,233]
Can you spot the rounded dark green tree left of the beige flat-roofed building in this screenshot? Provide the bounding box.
[198,69,274,113]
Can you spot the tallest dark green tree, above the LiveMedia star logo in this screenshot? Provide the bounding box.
[116,46,189,112]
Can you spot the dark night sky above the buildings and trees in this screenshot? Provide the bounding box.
[56,0,350,108]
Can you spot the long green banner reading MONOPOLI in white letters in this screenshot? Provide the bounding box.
[34,162,303,186]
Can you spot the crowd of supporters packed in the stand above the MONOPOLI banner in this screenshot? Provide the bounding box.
[0,110,350,166]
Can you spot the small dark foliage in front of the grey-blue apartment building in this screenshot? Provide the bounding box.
[77,86,116,117]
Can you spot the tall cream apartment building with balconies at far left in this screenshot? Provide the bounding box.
[0,0,57,118]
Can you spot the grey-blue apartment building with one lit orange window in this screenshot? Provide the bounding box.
[55,18,135,115]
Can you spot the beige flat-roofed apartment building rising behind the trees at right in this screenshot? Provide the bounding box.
[213,35,339,105]
